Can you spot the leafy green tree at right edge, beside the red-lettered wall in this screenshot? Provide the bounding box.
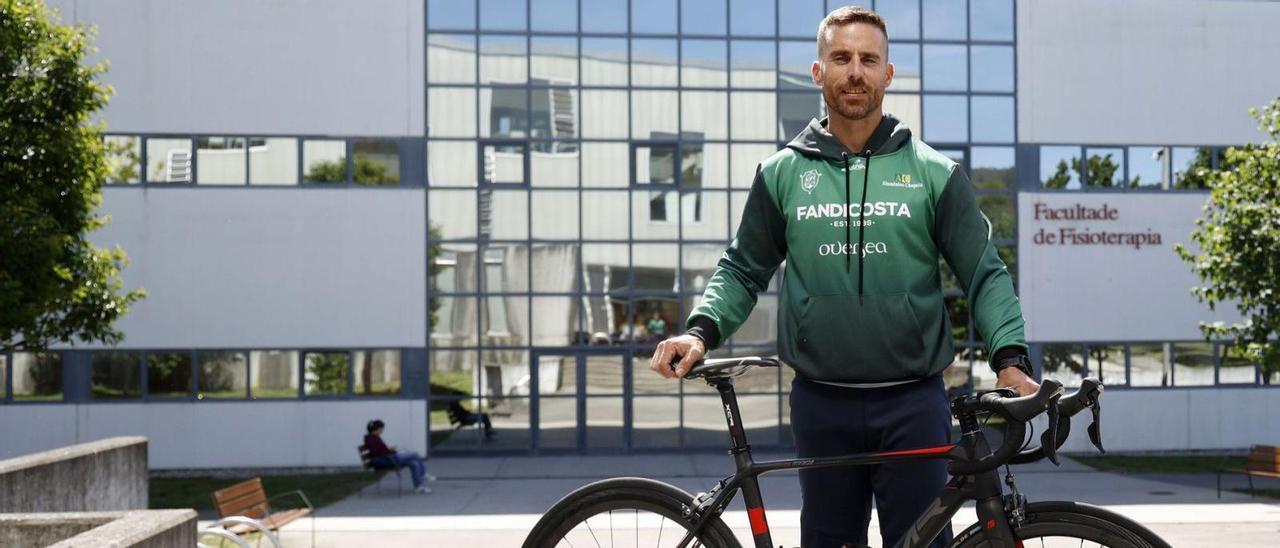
[1175,97,1280,382]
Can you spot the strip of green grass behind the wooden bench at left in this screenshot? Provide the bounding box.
[150,472,375,516]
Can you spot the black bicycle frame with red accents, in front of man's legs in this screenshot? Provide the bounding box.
[680,378,1016,548]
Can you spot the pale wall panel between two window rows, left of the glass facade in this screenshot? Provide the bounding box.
[76,188,426,348]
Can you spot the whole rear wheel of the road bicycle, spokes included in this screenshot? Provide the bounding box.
[524,478,740,548]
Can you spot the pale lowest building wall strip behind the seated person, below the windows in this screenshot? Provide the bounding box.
[0,399,426,468]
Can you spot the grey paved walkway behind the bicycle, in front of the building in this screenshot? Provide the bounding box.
[262,453,1280,547]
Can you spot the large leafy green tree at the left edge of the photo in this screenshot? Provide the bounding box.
[0,0,143,351]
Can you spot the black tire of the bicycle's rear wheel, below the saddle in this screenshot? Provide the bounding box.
[524,478,741,548]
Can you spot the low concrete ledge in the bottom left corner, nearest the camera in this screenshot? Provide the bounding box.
[0,510,196,548]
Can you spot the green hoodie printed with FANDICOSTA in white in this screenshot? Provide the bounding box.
[687,114,1027,383]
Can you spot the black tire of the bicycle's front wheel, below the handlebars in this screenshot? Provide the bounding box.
[951,502,1169,548]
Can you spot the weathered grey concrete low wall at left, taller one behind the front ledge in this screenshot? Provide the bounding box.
[0,437,147,513]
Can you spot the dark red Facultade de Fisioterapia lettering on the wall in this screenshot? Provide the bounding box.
[1032,202,1161,250]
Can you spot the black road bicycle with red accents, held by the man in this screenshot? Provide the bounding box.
[524,357,1169,548]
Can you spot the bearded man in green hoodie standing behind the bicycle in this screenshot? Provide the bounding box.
[649,8,1038,548]
